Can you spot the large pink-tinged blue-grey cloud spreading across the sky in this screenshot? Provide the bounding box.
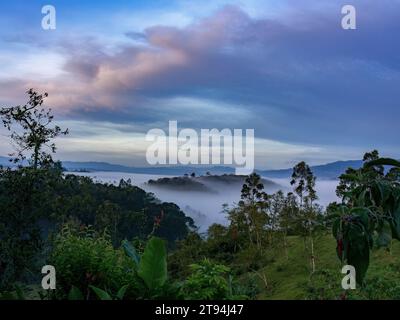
[0,0,400,165]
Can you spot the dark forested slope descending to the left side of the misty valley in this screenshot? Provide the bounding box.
[52,175,194,246]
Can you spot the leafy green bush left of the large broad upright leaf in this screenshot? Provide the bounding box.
[51,227,142,299]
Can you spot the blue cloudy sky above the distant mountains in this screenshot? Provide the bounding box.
[0,0,400,169]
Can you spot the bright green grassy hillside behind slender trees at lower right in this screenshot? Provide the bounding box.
[252,234,400,300]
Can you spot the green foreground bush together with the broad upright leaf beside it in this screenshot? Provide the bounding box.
[51,227,174,300]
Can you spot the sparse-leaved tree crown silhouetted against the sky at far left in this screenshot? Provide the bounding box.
[0,89,68,169]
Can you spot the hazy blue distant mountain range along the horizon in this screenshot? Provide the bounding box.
[0,156,362,179]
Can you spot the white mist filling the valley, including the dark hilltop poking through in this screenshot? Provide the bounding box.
[70,171,338,232]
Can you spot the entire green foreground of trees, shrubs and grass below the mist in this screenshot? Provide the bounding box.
[0,90,400,300]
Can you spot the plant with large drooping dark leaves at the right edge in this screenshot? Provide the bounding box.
[330,151,400,283]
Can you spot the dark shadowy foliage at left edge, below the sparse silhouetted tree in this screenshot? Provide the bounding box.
[0,166,61,290]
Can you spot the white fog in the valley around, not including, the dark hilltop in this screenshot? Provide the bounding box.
[70,172,337,232]
